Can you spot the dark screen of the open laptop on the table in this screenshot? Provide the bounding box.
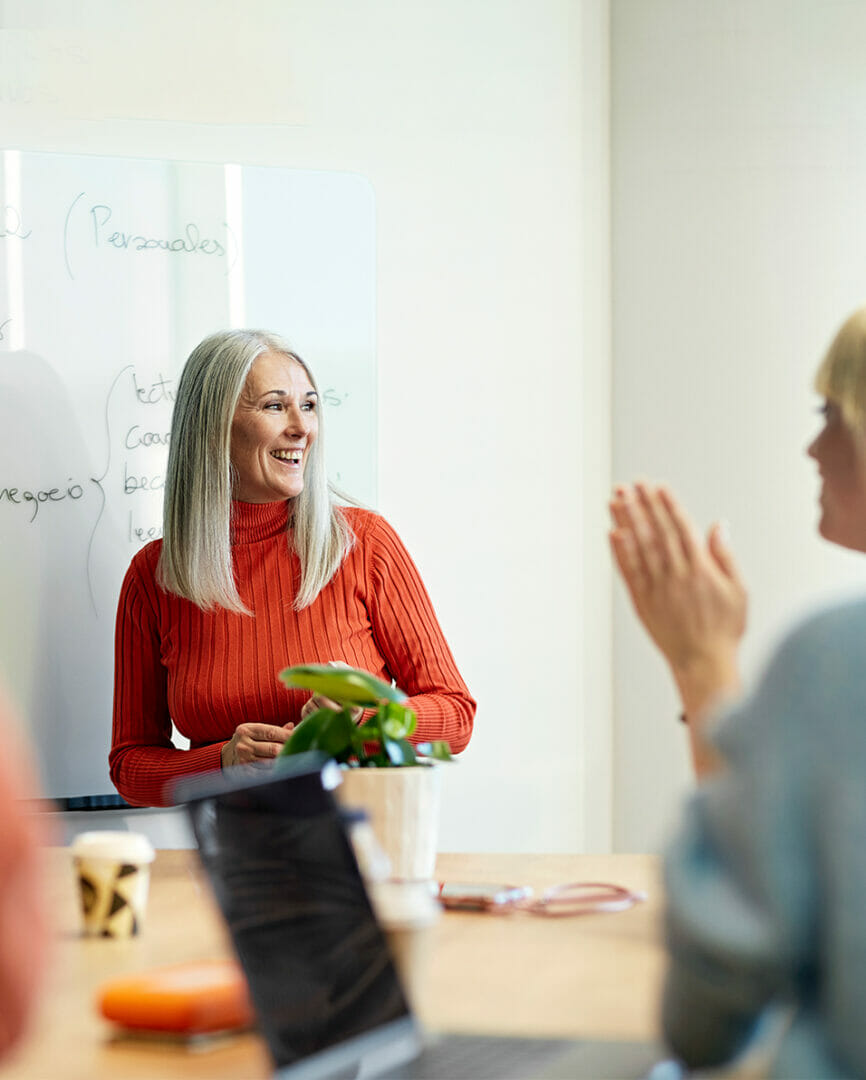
[180,760,409,1067]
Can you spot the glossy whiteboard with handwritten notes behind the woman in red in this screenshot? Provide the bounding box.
[0,150,377,799]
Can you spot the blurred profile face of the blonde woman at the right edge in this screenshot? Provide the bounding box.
[807,400,866,552]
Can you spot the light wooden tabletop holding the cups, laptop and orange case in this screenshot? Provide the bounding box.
[0,849,664,1080]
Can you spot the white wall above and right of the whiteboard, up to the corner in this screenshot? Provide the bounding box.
[0,0,611,851]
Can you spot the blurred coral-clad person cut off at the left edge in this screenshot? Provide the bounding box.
[0,696,49,1064]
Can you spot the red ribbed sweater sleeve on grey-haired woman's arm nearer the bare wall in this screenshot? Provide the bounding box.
[366,517,475,754]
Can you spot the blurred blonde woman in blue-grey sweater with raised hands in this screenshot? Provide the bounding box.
[611,308,866,1080]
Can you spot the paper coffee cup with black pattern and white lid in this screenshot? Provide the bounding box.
[72,831,154,937]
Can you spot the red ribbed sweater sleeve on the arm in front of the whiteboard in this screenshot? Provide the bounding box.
[108,559,222,806]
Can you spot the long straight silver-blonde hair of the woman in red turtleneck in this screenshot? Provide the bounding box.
[157,330,354,615]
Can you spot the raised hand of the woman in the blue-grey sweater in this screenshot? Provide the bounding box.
[610,484,747,773]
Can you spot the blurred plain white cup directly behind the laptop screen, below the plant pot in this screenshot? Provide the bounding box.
[369,881,442,1001]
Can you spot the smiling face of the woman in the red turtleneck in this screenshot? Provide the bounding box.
[230,352,319,502]
